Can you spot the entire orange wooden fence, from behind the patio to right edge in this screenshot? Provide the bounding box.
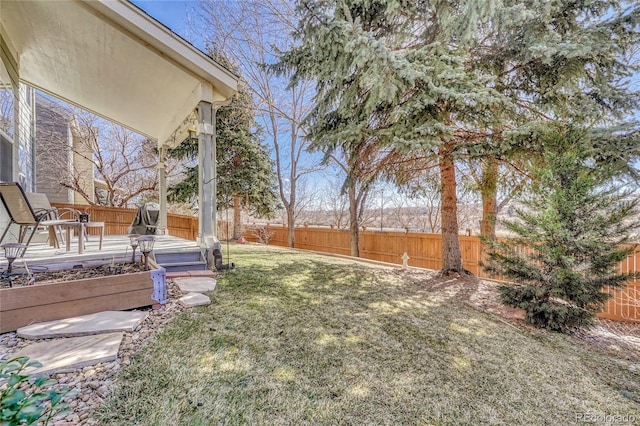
[38,208,640,322]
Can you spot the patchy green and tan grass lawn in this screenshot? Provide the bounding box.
[97,245,640,426]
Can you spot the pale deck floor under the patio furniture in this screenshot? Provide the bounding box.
[0,235,200,270]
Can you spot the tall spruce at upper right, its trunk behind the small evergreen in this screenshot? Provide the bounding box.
[469,0,640,240]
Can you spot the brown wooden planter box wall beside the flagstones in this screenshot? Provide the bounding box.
[0,262,164,333]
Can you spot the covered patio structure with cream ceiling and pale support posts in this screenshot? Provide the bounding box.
[0,0,238,263]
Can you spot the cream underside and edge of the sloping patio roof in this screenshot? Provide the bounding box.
[0,0,237,142]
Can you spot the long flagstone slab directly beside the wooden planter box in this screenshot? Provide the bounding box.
[17,311,147,339]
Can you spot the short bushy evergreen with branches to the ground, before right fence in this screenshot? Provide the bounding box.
[483,125,638,331]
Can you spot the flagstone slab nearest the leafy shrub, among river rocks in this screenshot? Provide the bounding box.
[12,332,123,374]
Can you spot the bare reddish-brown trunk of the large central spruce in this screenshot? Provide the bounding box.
[439,142,466,275]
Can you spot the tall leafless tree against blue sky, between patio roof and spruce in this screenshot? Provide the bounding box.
[196,0,320,246]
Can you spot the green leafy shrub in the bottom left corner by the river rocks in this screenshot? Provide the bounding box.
[0,357,70,426]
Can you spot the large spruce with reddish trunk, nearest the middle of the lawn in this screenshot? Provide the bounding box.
[280,0,503,273]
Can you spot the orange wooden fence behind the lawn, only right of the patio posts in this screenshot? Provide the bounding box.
[244,225,640,322]
